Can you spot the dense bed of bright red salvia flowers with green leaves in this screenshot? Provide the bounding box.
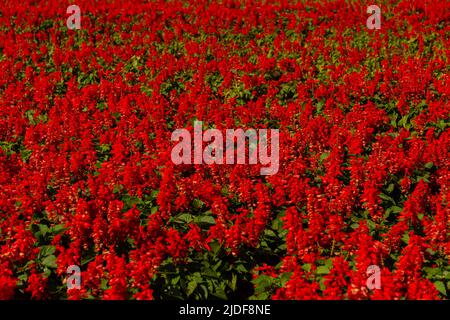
[0,0,450,299]
